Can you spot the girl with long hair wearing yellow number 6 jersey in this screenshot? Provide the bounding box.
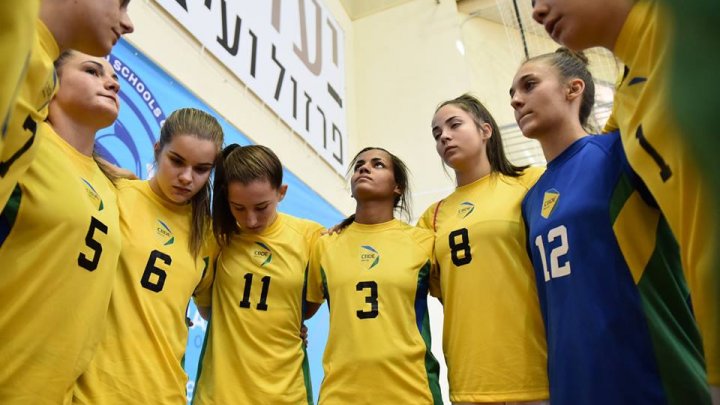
[73,108,223,405]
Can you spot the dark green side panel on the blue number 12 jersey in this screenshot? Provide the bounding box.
[638,216,710,405]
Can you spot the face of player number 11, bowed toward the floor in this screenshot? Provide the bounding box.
[228,179,287,234]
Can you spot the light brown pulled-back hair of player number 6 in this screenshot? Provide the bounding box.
[155,108,223,256]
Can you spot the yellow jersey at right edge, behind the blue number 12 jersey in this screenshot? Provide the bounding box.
[605,1,720,385]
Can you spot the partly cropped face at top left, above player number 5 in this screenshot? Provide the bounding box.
[60,0,134,56]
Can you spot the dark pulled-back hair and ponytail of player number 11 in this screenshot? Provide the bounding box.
[213,143,283,246]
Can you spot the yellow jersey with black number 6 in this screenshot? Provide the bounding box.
[73,180,218,405]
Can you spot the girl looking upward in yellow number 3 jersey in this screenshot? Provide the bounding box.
[307,148,442,405]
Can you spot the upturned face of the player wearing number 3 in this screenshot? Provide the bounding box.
[350,149,402,202]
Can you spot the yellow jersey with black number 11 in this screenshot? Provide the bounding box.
[193,213,323,405]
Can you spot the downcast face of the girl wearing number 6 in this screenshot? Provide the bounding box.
[150,134,218,204]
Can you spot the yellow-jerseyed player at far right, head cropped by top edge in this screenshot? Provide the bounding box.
[533,0,720,403]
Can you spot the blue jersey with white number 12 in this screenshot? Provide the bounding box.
[522,132,710,405]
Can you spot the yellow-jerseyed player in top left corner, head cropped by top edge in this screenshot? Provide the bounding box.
[0,0,133,209]
